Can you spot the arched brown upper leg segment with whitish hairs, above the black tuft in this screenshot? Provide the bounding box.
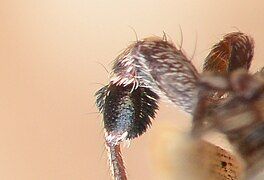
[111,37,199,113]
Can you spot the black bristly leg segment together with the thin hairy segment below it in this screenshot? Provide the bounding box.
[96,83,158,180]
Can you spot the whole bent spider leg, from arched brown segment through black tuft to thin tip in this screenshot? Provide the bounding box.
[96,38,202,180]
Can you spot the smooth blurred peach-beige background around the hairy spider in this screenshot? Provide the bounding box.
[0,0,264,180]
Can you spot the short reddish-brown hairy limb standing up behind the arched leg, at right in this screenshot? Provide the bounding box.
[203,32,254,74]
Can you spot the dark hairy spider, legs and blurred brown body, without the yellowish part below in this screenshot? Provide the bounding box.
[96,32,264,180]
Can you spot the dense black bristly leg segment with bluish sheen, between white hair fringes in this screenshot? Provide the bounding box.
[96,84,159,141]
